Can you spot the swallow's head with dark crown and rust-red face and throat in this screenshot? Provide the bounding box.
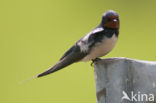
[101,10,120,29]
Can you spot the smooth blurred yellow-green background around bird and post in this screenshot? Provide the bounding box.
[0,0,156,103]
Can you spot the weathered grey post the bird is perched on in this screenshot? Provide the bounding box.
[94,58,156,103]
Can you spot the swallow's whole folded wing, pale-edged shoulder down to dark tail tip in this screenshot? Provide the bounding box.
[37,28,103,77]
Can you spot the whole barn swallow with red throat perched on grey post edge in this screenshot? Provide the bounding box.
[37,10,120,77]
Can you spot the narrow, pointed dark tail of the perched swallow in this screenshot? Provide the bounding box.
[37,60,72,77]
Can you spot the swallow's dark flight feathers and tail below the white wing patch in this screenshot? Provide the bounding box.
[37,45,87,77]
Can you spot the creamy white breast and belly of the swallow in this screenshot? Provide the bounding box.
[82,34,118,62]
